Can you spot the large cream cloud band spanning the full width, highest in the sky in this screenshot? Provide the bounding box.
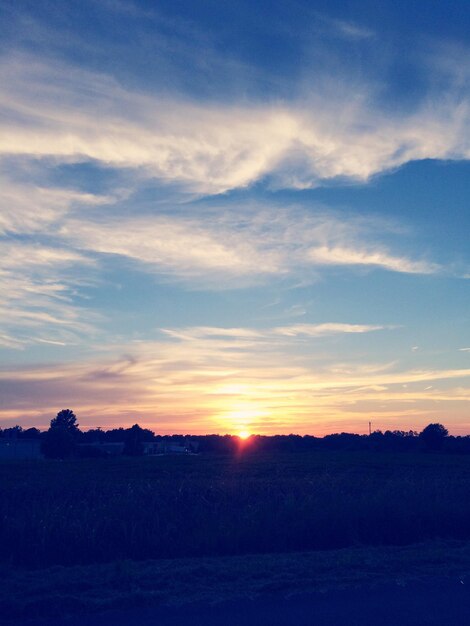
[0,55,470,194]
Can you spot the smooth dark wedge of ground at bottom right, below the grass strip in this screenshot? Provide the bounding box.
[18,580,470,626]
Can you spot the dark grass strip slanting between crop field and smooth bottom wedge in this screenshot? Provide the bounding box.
[4,542,470,625]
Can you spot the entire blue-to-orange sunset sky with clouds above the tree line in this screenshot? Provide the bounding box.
[0,0,470,436]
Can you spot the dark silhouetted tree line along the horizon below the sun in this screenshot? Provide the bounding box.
[0,409,470,459]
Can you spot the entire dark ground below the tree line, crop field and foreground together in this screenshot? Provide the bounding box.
[4,452,470,626]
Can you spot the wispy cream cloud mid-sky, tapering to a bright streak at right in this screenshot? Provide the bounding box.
[58,206,441,289]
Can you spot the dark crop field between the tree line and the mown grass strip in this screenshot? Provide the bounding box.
[0,452,470,568]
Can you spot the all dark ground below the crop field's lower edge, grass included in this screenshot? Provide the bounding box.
[6,542,470,626]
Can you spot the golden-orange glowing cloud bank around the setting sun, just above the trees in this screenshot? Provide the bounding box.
[0,323,470,434]
